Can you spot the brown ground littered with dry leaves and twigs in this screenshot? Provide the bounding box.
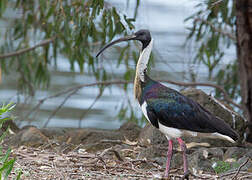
[7,143,252,180]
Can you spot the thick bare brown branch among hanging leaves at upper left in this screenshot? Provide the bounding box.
[0,37,56,59]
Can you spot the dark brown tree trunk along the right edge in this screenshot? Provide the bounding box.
[233,0,252,142]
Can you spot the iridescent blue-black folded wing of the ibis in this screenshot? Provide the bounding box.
[145,86,238,140]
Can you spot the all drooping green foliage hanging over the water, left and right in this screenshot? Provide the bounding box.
[0,0,240,126]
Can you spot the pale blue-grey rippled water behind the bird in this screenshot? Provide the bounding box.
[0,0,234,129]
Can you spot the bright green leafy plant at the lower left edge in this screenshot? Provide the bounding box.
[0,103,21,179]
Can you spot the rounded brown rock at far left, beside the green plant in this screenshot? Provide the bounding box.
[6,127,48,147]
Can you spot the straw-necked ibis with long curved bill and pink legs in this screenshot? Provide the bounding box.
[96,29,239,179]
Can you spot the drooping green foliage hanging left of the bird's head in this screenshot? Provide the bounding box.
[0,0,139,95]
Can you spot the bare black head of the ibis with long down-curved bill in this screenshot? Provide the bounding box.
[96,29,151,57]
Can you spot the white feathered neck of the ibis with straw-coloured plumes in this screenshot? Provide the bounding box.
[134,39,153,101]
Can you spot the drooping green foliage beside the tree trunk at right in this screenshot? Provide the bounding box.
[185,0,240,99]
